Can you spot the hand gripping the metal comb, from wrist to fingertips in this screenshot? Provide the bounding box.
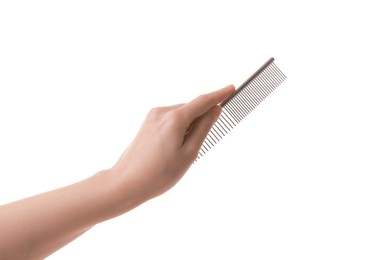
[111,85,235,202]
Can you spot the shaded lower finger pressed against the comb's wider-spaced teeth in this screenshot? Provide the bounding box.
[184,106,221,153]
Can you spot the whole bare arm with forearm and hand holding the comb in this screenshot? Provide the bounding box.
[0,86,235,259]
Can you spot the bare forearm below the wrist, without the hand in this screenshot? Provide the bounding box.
[0,171,143,259]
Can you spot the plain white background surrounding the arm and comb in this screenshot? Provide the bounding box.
[0,1,390,260]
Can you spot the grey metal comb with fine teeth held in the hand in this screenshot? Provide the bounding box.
[198,58,287,159]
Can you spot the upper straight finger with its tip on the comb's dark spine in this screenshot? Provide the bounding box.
[180,85,235,122]
